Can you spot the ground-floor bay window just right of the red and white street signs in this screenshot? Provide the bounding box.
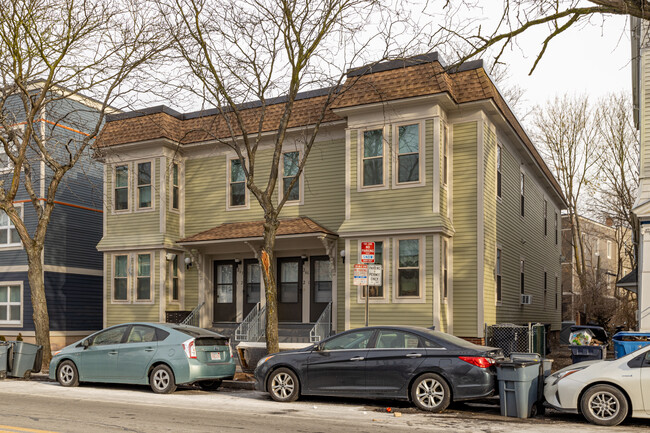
[393,237,426,303]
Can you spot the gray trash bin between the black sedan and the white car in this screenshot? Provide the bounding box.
[496,354,543,418]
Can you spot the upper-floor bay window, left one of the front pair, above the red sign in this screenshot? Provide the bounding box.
[358,127,387,189]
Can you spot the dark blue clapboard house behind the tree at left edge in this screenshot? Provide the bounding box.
[0,89,109,350]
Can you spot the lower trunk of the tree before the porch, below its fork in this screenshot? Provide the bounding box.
[260,215,280,353]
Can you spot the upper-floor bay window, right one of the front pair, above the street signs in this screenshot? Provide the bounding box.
[393,122,425,188]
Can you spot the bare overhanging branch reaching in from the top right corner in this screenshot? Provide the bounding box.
[438,0,650,73]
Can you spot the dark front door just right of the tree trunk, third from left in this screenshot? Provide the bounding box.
[278,257,302,322]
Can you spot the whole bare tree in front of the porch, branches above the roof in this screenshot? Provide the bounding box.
[157,0,420,353]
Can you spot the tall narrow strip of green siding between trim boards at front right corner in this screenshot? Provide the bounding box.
[452,122,478,337]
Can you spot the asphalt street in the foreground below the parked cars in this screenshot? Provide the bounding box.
[0,380,650,433]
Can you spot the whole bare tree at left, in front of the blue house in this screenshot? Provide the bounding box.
[0,0,164,368]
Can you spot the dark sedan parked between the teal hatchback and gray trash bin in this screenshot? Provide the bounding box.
[255,326,503,412]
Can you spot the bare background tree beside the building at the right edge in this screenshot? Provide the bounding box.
[593,94,640,277]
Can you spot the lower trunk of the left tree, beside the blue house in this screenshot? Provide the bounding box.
[26,247,52,371]
